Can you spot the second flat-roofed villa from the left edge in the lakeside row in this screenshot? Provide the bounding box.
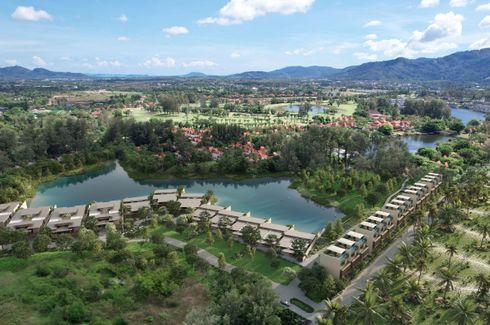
[7,207,51,234]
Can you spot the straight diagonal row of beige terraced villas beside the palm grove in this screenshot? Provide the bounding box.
[319,173,442,278]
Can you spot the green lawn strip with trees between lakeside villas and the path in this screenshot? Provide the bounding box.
[152,226,301,284]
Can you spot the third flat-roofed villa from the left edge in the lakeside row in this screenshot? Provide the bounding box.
[46,205,86,235]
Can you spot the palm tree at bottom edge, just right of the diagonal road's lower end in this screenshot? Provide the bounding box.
[350,282,385,325]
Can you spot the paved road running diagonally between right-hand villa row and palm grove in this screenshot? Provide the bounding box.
[334,226,414,306]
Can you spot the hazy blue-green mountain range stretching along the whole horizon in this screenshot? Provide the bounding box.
[0,49,490,82]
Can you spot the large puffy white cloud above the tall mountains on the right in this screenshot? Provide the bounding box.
[364,12,464,57]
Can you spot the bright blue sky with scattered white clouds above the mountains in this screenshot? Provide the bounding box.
[0,0,490,75]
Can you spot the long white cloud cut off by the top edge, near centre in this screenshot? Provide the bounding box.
[198,0,315,26]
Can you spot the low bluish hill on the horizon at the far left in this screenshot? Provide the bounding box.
[0,66,90,80]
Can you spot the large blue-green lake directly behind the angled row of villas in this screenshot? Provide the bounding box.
[30,163,342,232]
